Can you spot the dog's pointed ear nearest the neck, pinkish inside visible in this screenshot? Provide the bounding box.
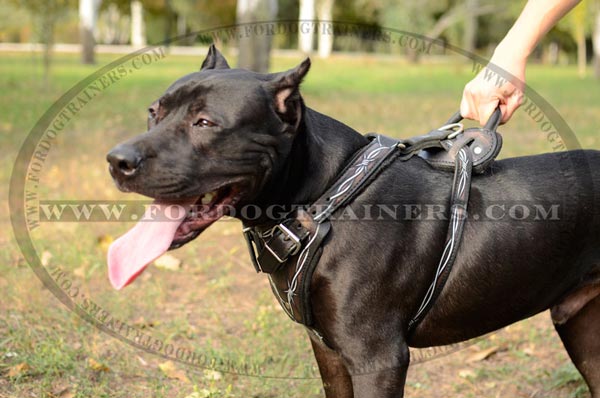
[269,58,310,128]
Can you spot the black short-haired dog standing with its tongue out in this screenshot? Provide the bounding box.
[108,47,600,398]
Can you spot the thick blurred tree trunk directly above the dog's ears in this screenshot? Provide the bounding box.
[236,0,277,73]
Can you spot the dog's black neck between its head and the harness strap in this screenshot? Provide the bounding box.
[246,108,368,225]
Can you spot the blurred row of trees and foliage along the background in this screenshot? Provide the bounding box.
[0,0,600,77]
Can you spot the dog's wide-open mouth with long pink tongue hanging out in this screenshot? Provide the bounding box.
[108,184,242,289]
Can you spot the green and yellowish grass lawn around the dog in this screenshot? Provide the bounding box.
[0,50,600,398]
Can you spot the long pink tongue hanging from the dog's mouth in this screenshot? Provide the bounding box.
[108,203,190,289]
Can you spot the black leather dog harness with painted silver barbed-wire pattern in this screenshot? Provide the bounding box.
[244,109,502,339]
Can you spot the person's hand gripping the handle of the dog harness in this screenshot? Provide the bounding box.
[460,54,526,126]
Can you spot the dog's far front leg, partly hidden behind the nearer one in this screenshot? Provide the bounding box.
[310,336,354,398]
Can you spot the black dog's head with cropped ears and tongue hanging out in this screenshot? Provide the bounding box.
[107,46,310,287]
